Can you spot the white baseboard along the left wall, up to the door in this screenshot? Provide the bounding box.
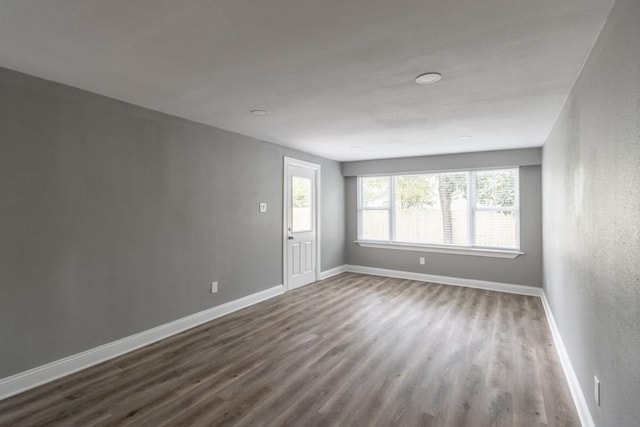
[0,285,284,400]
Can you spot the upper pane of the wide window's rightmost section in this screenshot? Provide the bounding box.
[476,169,517,208]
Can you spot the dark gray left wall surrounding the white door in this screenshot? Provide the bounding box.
[0,69,346,378]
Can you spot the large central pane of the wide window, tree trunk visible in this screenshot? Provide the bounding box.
[394,172,469,245]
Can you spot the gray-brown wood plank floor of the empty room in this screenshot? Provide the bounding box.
[0,273,579,426]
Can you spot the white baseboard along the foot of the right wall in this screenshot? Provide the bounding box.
[541,292,595,427]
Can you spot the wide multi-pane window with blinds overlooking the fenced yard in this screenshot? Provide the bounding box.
[358,169,520,250]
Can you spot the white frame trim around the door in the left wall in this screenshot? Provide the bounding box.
[282,156,322,291]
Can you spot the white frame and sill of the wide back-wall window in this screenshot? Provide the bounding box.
[356,166,523,258]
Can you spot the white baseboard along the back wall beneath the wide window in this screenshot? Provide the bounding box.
[346,265,542,297]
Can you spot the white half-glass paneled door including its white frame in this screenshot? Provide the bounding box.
[284,157,320,289]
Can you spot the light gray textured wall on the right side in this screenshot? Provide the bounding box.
[543,0,640,427]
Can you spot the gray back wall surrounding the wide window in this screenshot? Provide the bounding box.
[343,149,542,287]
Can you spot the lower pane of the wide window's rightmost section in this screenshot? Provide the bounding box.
[476,211,517,248]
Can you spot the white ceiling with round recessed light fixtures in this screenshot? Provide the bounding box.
[0,0,613,160]
